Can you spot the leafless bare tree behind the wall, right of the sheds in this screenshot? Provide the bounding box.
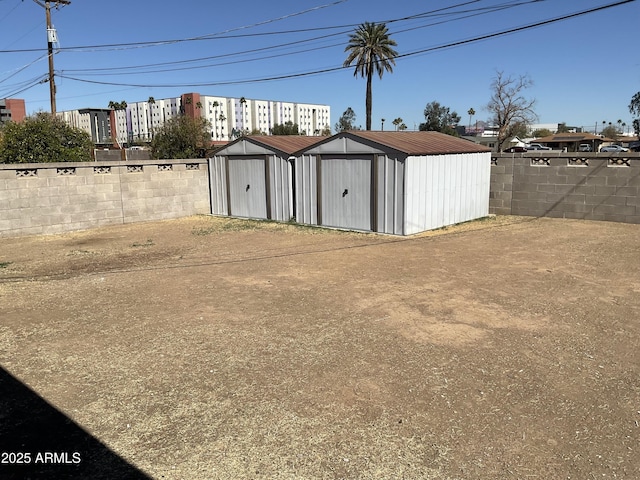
[487,71,538,152]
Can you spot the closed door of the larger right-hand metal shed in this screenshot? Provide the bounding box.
[321,156,373,230]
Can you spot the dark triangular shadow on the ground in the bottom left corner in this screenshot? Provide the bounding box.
[0,367,150,480]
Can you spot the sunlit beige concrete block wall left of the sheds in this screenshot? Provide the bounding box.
[0,159,210,237]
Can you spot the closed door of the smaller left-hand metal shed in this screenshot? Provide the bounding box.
[229,158,267,218]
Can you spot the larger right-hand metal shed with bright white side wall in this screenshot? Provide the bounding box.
[295,130,491,235]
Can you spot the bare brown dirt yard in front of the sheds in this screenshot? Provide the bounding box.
[0,216,640,479]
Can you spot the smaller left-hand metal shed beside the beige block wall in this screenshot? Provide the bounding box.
[209,135,324,222]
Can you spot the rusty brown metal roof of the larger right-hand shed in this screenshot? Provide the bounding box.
[343,130,491,155]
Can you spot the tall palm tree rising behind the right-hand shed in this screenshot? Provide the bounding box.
[343,22,398,130]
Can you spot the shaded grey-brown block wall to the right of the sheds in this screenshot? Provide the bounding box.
[489,153,640,224]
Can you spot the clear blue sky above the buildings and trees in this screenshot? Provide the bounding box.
[0,0,640,129]
